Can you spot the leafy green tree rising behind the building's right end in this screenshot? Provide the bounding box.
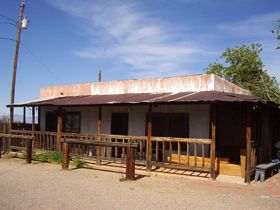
[206,44,280,103]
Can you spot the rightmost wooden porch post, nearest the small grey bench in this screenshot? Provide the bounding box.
[245,106,252,183]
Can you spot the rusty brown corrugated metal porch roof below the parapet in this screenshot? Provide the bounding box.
[8,91,265,107]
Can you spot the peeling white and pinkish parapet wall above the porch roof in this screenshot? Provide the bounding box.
[40,74,251,99]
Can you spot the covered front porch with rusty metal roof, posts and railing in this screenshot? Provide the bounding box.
[6,91,271,182]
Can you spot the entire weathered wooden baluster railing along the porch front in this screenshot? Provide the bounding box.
[8,130,211,172]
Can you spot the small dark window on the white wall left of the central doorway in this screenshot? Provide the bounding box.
[63,112,81,133]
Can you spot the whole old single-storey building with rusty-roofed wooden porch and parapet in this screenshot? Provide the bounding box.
[7,74,279,181]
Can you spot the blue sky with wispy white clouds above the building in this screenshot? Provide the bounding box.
[0,0,280,115]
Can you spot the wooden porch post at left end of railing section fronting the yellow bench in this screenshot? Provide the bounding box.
[146,104,152,171]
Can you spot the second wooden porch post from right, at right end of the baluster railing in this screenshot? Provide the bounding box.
[210,104,217,180]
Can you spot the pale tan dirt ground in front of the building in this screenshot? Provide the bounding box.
[0,159,280,210]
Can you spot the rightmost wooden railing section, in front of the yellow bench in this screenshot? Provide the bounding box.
[152,137,211,172]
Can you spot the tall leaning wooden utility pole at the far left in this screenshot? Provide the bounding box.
[9,0,25,129]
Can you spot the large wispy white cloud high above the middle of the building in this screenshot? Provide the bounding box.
[47,0,211,76]
